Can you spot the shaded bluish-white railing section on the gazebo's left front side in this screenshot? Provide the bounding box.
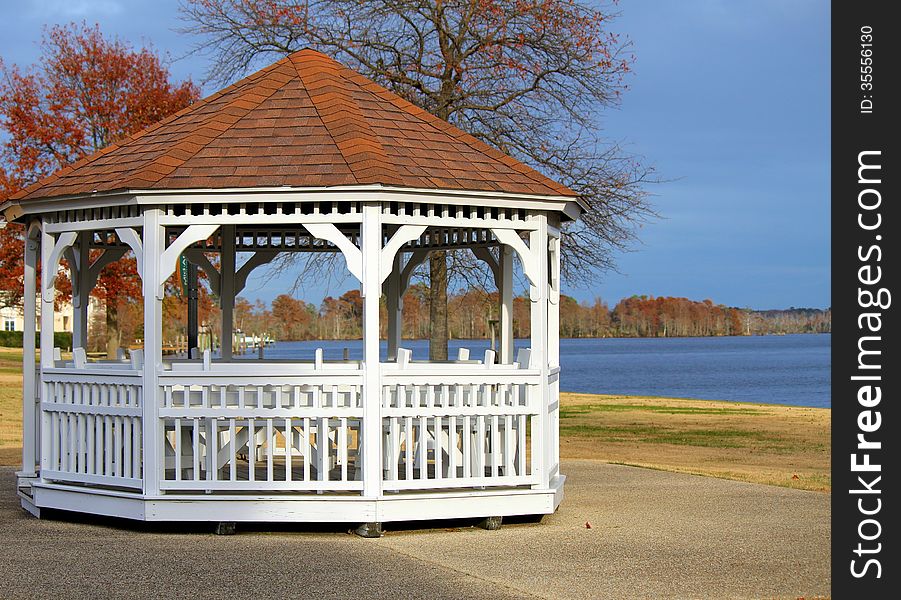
[40,368,143,489]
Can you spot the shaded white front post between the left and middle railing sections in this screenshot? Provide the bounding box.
[141,208,166,496]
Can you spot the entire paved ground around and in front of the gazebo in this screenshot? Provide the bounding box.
[0,461,831,599]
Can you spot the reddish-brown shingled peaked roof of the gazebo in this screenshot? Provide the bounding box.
[10,49,576,203]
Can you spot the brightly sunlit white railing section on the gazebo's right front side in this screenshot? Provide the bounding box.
[382,363,542,490]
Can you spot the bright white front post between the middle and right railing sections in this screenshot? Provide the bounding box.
[360,202,382,498]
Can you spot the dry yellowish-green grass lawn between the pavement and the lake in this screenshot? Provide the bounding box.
[0,348,832,491]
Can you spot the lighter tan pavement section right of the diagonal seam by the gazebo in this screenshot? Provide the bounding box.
[378,460,831,598]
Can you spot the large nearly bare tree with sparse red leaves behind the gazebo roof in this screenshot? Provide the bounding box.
[181,0,654,359]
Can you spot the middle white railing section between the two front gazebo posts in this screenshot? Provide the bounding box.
[159,365,363,492]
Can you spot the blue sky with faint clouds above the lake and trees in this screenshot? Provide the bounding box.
[0,0,831,309]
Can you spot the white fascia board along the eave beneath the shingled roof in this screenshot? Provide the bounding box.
[0,185,584,221]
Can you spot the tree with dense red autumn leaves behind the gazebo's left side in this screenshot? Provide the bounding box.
[0,24,200,352]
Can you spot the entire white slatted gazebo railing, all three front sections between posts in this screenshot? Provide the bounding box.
[40,349,559,493]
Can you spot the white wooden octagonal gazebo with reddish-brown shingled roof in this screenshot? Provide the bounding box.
[0,50,581,533]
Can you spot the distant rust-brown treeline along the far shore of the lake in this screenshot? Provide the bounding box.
[211,285,832,340]
